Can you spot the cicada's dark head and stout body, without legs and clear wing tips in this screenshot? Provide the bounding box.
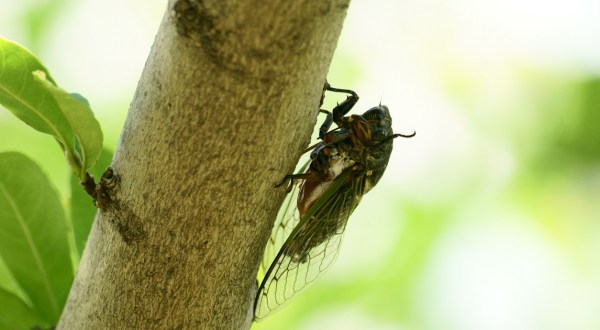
[289,106,393,262]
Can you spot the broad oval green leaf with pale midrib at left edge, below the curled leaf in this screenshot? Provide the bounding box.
[0,152,73,324]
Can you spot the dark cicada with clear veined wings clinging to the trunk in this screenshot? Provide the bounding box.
[254,84,415,320]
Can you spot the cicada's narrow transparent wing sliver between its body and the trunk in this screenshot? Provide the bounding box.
[258,160,310,281]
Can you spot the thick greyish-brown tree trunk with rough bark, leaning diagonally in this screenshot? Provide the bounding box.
[59,0,349,329]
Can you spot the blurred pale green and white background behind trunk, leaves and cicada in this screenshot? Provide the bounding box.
[0,0,600,330]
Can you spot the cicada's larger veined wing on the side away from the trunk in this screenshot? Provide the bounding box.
[254,168,365,320]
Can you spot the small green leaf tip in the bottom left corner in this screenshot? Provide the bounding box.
[0,288,44,330]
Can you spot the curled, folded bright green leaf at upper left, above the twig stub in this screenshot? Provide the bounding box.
[0,38,102,180]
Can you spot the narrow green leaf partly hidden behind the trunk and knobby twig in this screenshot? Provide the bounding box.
[71,149,113,257]
